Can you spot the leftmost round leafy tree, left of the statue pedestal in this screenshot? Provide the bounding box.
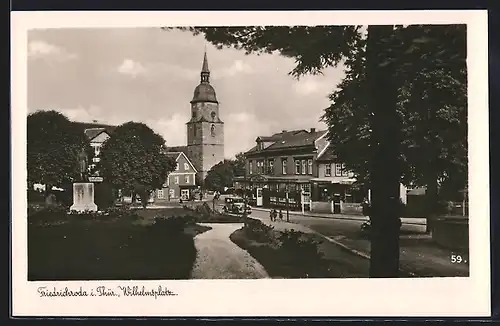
[27,110,90,196]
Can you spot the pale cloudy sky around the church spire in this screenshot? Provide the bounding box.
[28,28,343,158]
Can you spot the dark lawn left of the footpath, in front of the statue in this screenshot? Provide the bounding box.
[28,209,210,281]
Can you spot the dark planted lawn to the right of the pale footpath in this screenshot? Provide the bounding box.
[230,221,369,278]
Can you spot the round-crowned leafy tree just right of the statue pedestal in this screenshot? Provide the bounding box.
[100,122,176,208]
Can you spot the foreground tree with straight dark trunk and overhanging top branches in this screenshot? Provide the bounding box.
[174,26,466,277]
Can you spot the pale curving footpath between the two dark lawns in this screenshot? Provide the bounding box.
[191,223,268,279]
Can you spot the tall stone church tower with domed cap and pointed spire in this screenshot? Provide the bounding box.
[186,51,224,180]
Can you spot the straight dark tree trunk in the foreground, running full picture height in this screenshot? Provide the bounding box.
[367,26,401,277]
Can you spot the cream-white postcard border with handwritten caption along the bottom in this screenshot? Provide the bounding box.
[11,10,490,317]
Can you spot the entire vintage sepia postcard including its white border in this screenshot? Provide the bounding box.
[11,10,490,317]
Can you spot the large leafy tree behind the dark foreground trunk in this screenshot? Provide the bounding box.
[323,25,467,233]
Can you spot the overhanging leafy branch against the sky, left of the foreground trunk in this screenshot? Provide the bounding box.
[164,26,361,78]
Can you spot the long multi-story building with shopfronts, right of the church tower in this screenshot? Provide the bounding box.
[235,128,368,212]
